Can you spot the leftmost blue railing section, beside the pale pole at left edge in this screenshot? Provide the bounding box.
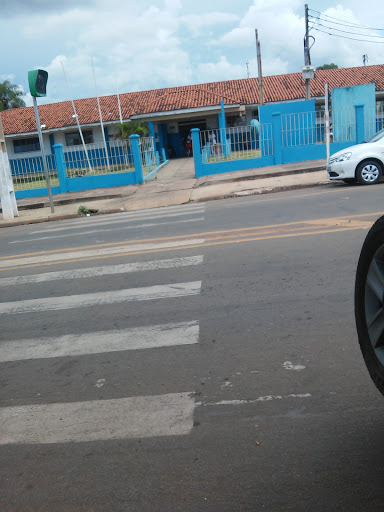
[9,155,59,191]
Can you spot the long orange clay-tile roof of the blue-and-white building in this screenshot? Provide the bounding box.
[0,64,384,135]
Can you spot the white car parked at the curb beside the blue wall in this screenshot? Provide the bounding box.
[327,129,384,185]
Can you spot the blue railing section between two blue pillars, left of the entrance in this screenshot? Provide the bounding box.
[64,140,134,178]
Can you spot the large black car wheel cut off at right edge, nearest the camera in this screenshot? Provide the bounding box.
[355,216,384,395]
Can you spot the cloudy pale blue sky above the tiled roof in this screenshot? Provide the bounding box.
[0,0,384,105]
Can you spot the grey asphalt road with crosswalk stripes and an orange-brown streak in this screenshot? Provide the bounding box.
[0,185,384,512]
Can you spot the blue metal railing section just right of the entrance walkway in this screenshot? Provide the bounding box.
[200,123,273,163]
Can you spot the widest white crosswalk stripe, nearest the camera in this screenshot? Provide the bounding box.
[0,392,194,445]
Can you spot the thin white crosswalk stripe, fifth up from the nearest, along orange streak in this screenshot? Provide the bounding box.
[0,239,204,268]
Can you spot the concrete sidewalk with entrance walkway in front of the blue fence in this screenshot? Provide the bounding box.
[0,158,330,227]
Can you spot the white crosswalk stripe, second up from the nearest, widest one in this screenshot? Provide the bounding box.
[0,321,199,363]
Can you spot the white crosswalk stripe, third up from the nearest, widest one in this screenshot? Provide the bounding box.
[0,281,201,315]
